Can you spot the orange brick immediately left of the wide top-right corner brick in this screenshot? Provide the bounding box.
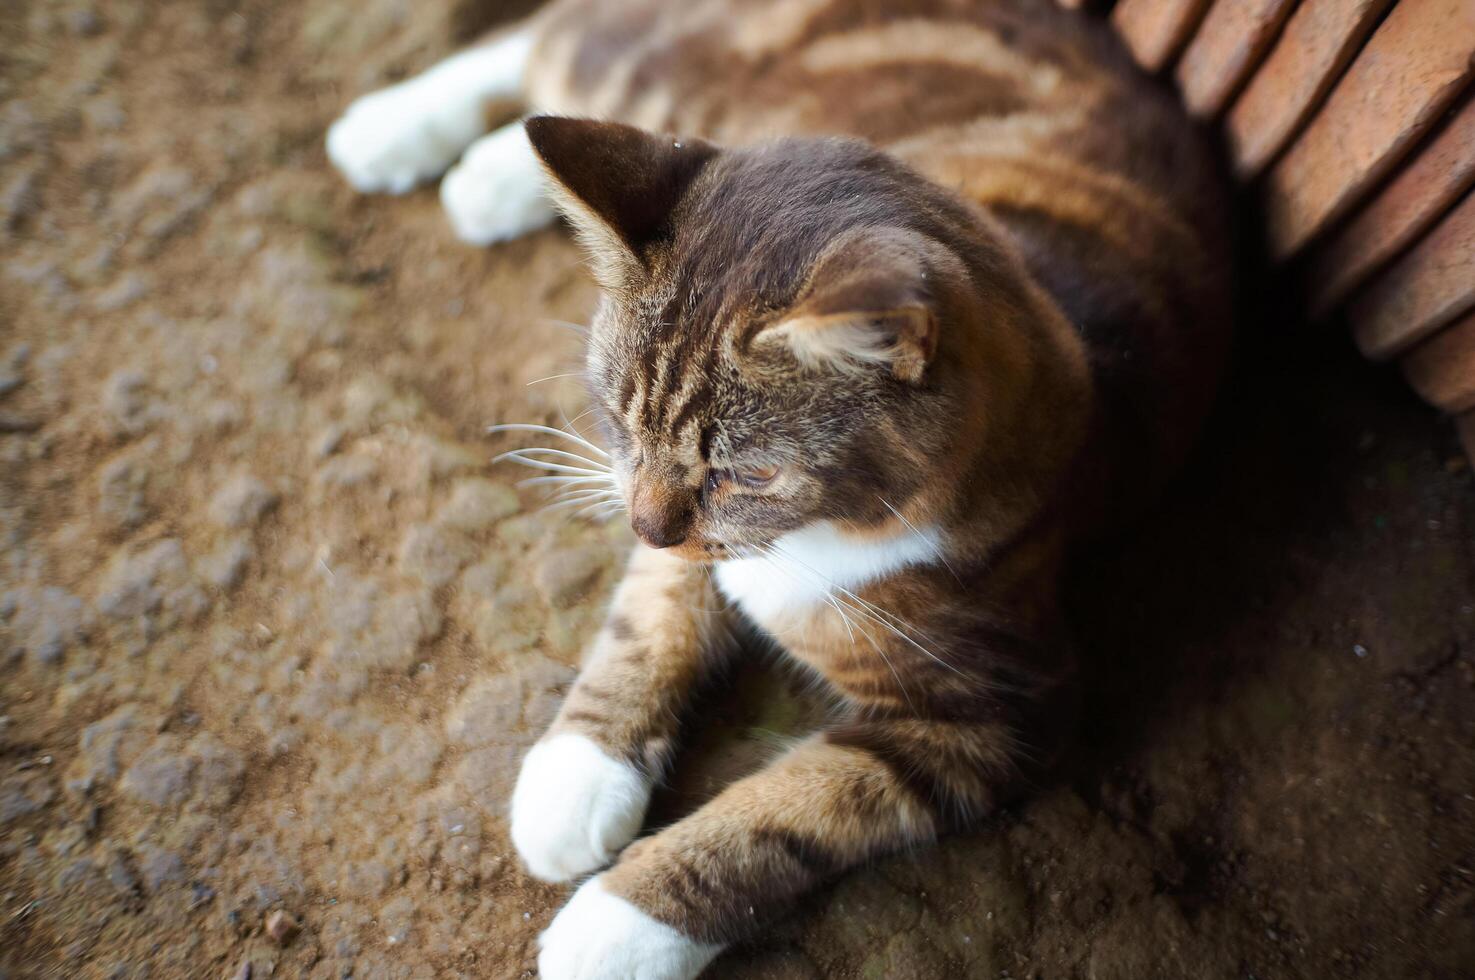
[1224,0,1391,180]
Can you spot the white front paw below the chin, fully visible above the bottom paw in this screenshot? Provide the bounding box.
[512,734,650,881]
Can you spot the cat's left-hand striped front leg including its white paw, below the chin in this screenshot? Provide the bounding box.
[512,545,729,881]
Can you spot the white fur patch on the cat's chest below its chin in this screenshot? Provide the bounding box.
[715,522,943,624]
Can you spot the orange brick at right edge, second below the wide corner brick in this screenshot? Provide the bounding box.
[1347,193,1475,360]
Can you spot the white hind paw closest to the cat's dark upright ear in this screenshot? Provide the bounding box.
[441,123,556,245]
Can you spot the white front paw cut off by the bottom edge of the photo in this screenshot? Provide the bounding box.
[538,878,721,980]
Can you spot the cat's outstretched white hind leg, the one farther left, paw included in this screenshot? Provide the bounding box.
[327,30,532,193]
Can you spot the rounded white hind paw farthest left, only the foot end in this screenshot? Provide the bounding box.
[327,71,487,193]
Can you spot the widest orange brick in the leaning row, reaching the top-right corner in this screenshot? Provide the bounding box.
[1266,0,1475,260]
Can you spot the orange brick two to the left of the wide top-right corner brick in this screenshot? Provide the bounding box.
[1176,0,1295,120]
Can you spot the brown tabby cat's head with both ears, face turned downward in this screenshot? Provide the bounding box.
[527,117,1018,559]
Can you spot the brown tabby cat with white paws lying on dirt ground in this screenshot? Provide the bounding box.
[327,0,1232,980]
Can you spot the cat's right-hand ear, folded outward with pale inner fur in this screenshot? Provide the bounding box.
[755,229,937,384]
